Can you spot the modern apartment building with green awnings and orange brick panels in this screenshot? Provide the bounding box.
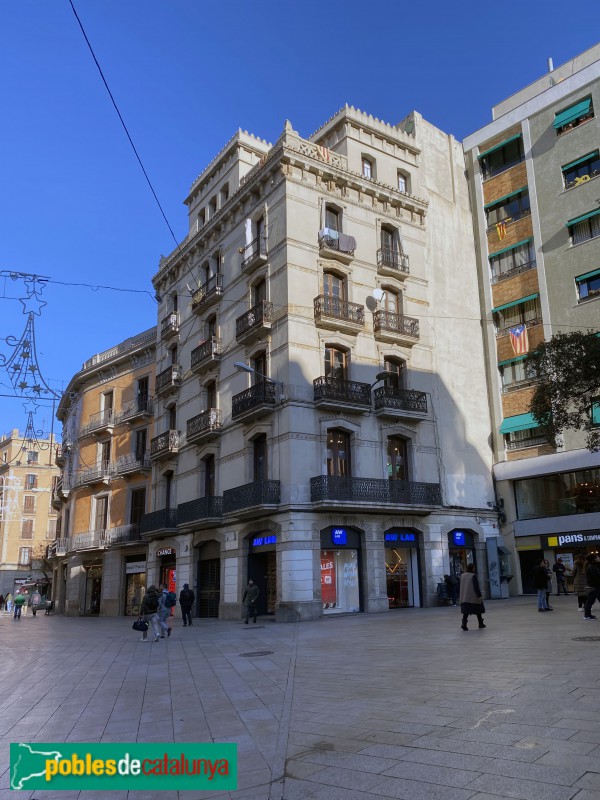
[464,45,600,592]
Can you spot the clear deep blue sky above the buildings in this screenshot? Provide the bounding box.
[0,0,598,433]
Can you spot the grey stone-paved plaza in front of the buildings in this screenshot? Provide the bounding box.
[0,596,600,800]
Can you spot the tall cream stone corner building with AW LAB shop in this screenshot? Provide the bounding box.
[148,106,496,621]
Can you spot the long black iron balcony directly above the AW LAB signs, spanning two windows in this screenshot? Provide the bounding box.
[310,475,442,513]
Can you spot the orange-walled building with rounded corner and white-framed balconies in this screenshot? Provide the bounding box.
[49,328,157,616]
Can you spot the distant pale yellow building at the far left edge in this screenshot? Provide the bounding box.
[0,429,59,597]
